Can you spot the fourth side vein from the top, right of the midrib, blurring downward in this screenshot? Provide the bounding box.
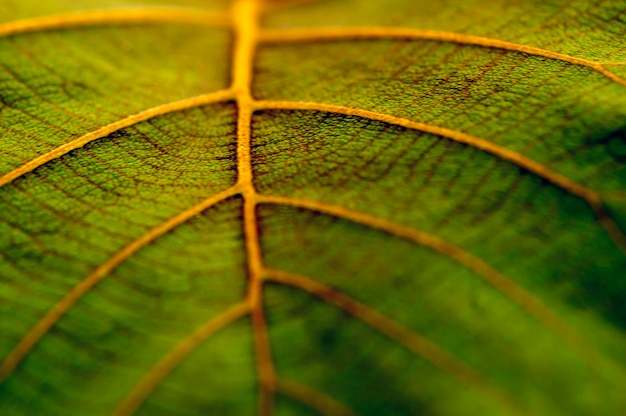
[265,270,517,410]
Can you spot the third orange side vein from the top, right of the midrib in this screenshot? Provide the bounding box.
[258,195,591,358]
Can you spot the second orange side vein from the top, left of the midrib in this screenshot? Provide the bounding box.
[0,89,234,187]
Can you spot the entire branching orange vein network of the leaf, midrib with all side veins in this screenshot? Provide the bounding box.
[0,0,626,416]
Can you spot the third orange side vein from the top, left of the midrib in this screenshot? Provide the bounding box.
[0,186,239,384]
